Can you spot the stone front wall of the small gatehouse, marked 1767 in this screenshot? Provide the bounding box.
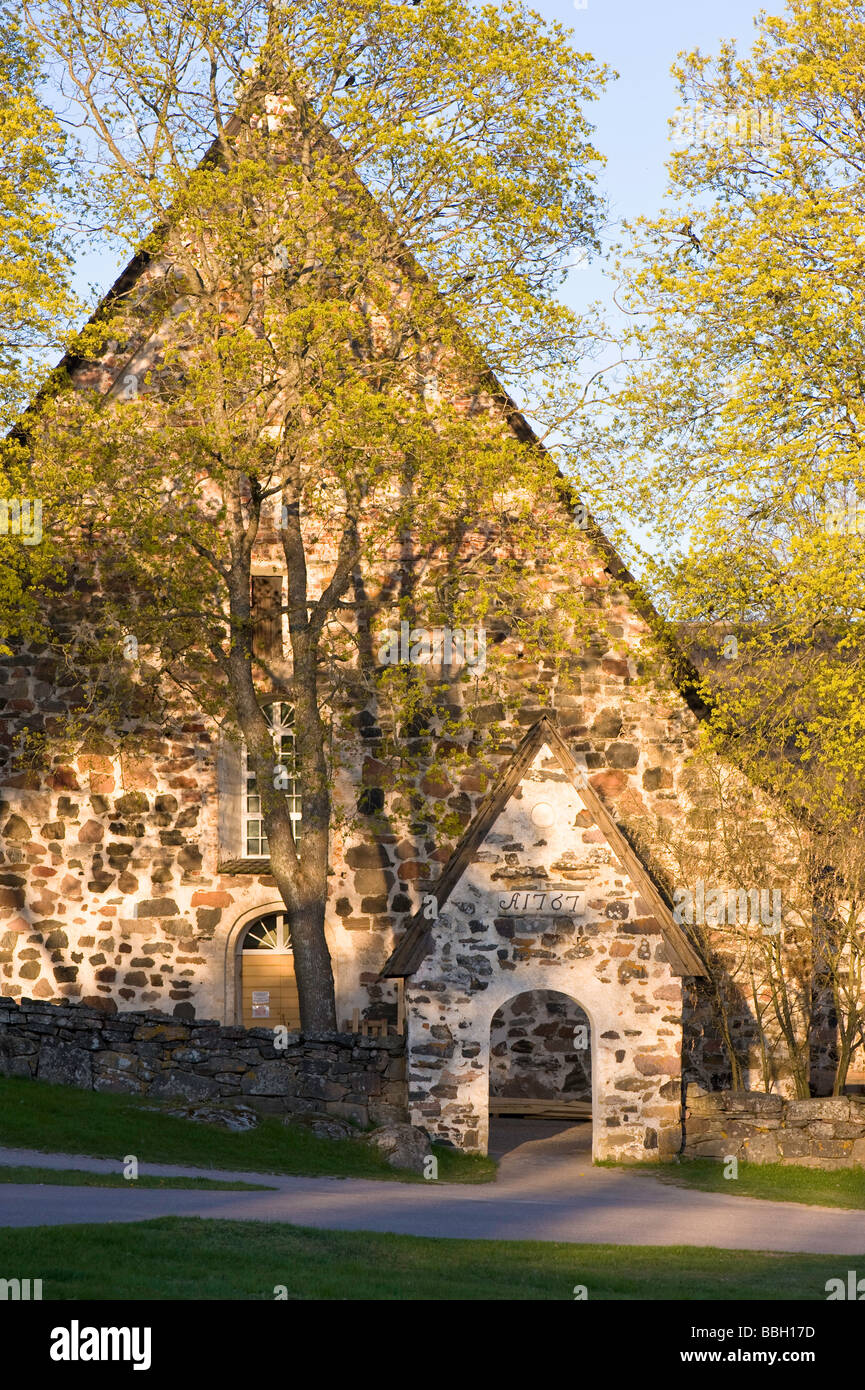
[406,746,681,1159]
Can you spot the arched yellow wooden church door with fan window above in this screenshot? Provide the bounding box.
[238,912,300,1031]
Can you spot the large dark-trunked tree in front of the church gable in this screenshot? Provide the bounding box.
[22,0,617,1030]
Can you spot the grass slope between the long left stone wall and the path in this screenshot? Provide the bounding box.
[0,1076,495,1183]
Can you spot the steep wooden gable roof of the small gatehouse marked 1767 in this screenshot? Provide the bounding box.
[381,714,706,979]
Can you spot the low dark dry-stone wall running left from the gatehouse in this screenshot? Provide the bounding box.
[0,998,406,1125]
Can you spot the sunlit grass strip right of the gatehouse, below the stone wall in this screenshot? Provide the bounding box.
[615,1158,865,1211]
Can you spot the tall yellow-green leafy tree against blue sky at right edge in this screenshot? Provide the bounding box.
[574,0,865,1084]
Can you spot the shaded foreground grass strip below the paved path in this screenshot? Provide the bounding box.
[0,1216,854,1302]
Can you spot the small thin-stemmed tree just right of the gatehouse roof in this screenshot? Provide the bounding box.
[641,745,817,1097]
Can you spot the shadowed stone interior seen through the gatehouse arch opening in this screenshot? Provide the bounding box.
[490,990,591,1101]
